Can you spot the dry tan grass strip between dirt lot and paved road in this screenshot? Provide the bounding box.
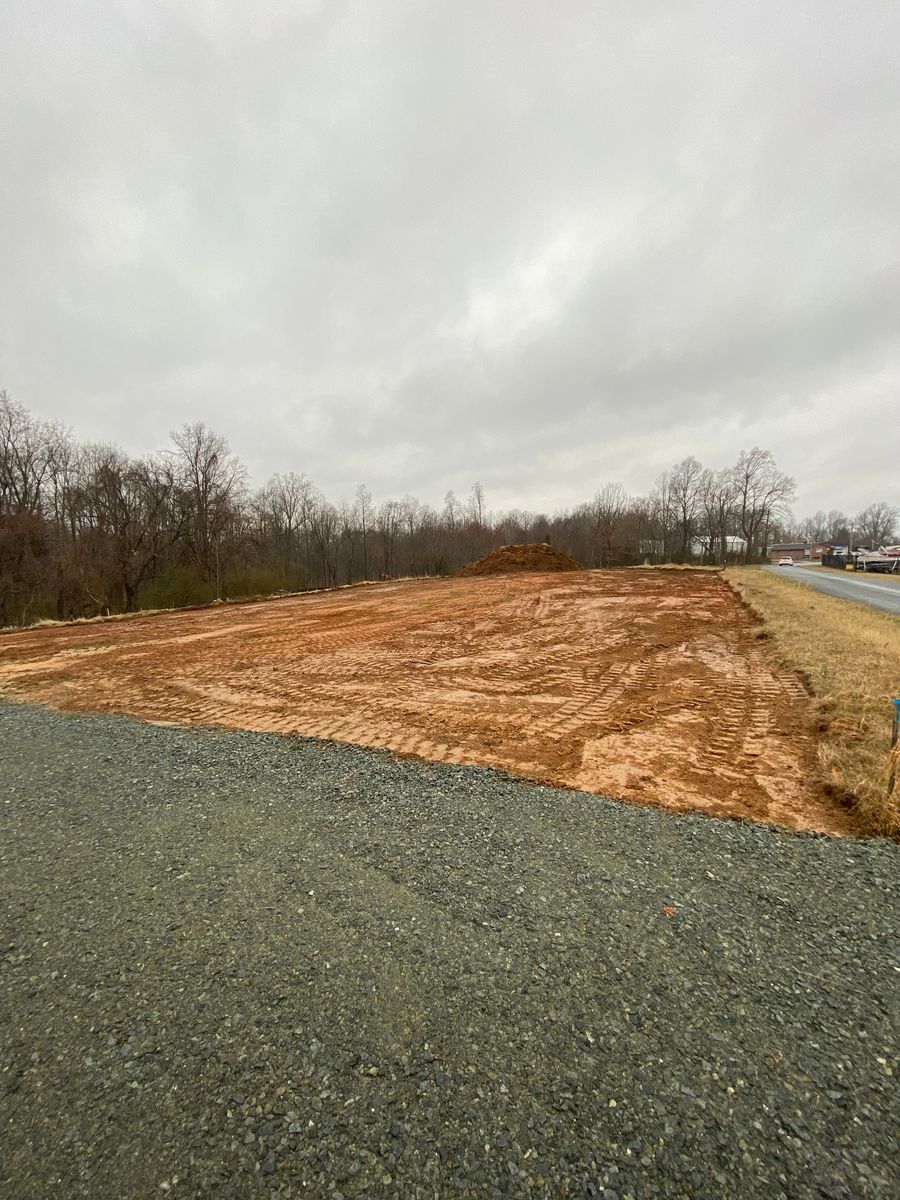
[725,566,900,838]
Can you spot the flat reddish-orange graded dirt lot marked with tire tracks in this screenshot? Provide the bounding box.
[0,570,853,834]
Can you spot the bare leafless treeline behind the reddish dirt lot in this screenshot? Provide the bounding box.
[0,392,897,625]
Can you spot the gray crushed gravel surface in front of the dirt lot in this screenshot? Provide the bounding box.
[0,704,900,1200]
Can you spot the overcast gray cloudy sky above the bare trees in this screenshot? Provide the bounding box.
[0,0,900,515]
